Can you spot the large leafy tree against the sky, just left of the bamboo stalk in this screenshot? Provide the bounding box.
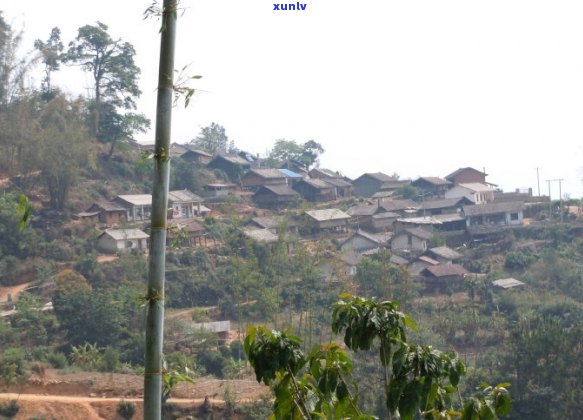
[63,22,149,156]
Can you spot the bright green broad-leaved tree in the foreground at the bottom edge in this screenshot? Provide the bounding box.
[245,295,510,420]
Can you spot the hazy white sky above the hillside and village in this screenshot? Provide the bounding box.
[0,0,583,198]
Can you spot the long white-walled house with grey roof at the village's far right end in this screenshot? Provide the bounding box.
[462,201,524,227]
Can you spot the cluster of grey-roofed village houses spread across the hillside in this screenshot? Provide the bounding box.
[75,143,560,291]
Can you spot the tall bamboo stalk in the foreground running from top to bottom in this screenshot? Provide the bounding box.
[144,0,177,420]
